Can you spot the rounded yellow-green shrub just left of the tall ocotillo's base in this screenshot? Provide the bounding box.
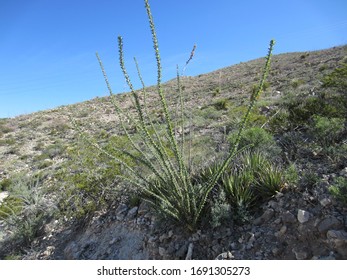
[56,138,127,220]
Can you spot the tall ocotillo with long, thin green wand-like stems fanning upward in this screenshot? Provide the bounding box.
[72,0,274,231]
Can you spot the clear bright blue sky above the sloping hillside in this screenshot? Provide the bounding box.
[0,0,347,117]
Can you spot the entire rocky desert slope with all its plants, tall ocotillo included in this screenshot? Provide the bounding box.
[0,1,347,259]
